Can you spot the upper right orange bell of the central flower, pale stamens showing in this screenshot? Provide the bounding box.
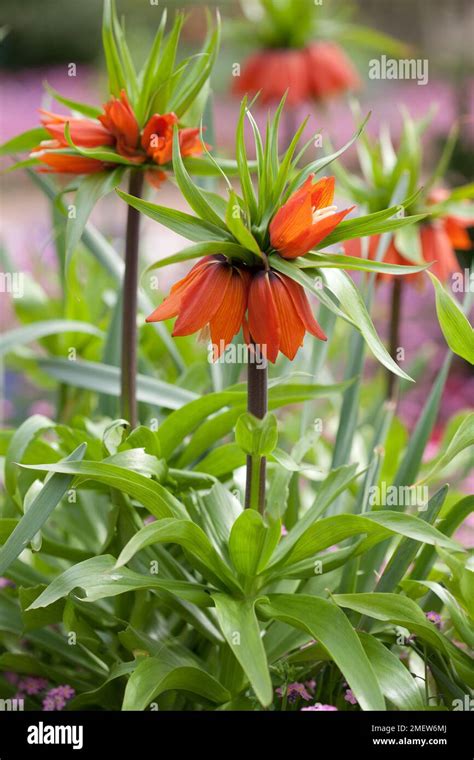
[270,174,355,259]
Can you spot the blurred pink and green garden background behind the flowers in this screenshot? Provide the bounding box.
[0,0,474,532]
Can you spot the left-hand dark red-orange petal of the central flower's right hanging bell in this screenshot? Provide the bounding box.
[248,272,280,362]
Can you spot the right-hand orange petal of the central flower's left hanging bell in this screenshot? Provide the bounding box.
[210,269,250,361]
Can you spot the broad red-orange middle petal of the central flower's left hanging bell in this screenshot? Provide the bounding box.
[173,262,232,336]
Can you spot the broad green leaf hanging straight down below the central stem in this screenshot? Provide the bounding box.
[212,593,273,707]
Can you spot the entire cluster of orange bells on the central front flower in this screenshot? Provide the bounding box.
[147,175,351,362]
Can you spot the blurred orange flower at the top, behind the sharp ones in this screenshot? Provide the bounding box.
[233,42,360,105]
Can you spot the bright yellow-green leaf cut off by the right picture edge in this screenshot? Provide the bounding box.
[428,272,474,364]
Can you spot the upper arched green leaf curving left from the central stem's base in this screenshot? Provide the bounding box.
[117,519,241,592]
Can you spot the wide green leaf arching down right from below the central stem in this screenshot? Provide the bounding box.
[258,594,385,710]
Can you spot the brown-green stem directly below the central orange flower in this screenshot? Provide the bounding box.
[245,344,268,512]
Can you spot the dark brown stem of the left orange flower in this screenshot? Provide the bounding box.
[121,170,143,428]
